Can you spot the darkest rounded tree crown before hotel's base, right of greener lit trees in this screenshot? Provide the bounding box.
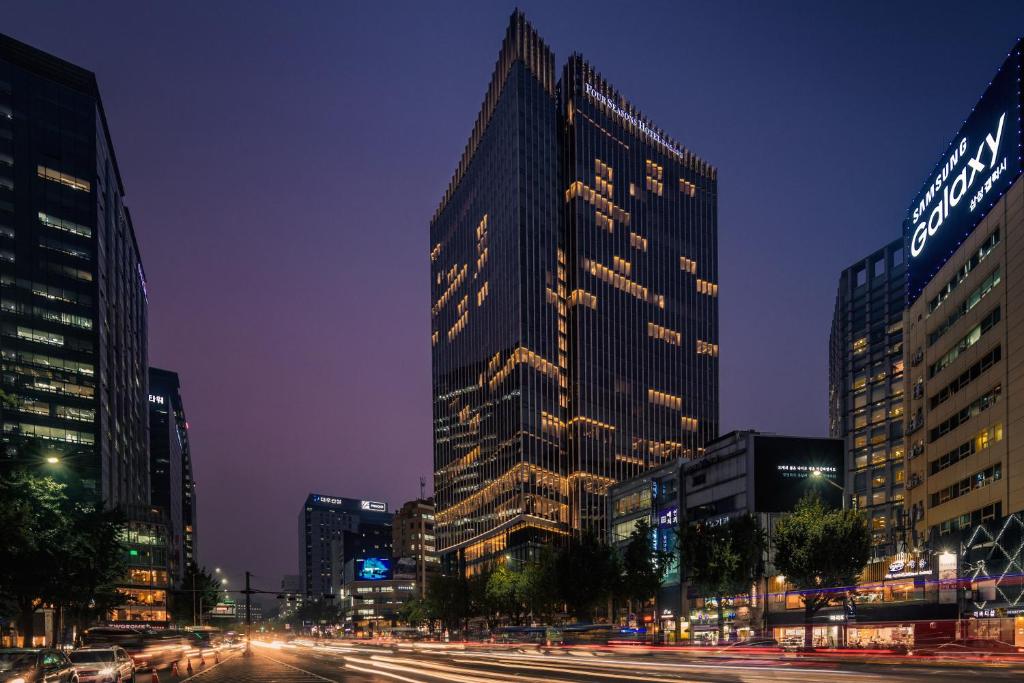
[555,531,622,622]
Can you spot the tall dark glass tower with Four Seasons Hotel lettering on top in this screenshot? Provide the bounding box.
[430,11,719,571]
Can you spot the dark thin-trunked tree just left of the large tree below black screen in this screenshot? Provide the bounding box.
[680,513,764,642]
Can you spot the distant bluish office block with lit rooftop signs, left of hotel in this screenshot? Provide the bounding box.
[299,494,393,599]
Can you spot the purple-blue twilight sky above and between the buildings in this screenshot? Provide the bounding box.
[0,0,1024,589]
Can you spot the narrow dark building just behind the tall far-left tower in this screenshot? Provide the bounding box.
[150,368,197,587]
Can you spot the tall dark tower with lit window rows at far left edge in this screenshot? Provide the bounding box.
[0,36,150,506]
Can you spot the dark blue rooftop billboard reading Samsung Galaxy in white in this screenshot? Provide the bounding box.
[903,43,1021,303]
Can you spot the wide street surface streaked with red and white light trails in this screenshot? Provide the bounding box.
[151,643,1024,683]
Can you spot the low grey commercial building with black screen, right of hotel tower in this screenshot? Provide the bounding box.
[608,430,844,641]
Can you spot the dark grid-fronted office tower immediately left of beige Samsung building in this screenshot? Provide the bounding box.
[828,238,906,558]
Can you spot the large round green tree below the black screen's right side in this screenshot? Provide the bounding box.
[773,494,871,648]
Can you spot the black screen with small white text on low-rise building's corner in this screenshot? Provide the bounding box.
[754,435,844,512]
